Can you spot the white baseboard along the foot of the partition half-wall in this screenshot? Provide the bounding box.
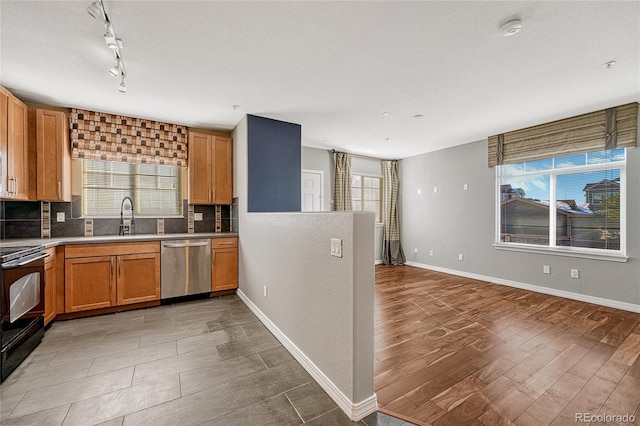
[237,289,378,421]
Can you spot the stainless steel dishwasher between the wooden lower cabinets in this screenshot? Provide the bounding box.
[160,240,211,299]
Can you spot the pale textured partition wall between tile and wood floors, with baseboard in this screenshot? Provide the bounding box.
[233,119,376,418]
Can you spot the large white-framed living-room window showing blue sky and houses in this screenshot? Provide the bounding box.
[496,148,626,256]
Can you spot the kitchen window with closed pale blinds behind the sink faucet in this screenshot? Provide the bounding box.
[82,160,182,217]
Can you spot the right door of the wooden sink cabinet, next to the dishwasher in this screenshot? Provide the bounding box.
[117,253,160,305]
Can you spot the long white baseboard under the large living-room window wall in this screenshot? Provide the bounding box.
[405,262,640,313]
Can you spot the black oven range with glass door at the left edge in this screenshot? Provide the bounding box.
[0,247,48,382]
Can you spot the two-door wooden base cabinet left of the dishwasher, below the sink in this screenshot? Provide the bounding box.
[65,243,160,313]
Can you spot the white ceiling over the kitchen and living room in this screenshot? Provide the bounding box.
[0,0,640,158]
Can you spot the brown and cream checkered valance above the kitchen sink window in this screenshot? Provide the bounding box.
[69,109,187,167]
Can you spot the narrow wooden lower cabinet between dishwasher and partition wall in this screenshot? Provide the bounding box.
[211,238,238,291]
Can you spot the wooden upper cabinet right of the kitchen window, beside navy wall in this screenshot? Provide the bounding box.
[189,131,233,204]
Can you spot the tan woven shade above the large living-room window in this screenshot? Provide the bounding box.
[488,102,638,167]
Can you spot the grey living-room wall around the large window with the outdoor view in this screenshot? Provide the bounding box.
[400,140,640,310]
